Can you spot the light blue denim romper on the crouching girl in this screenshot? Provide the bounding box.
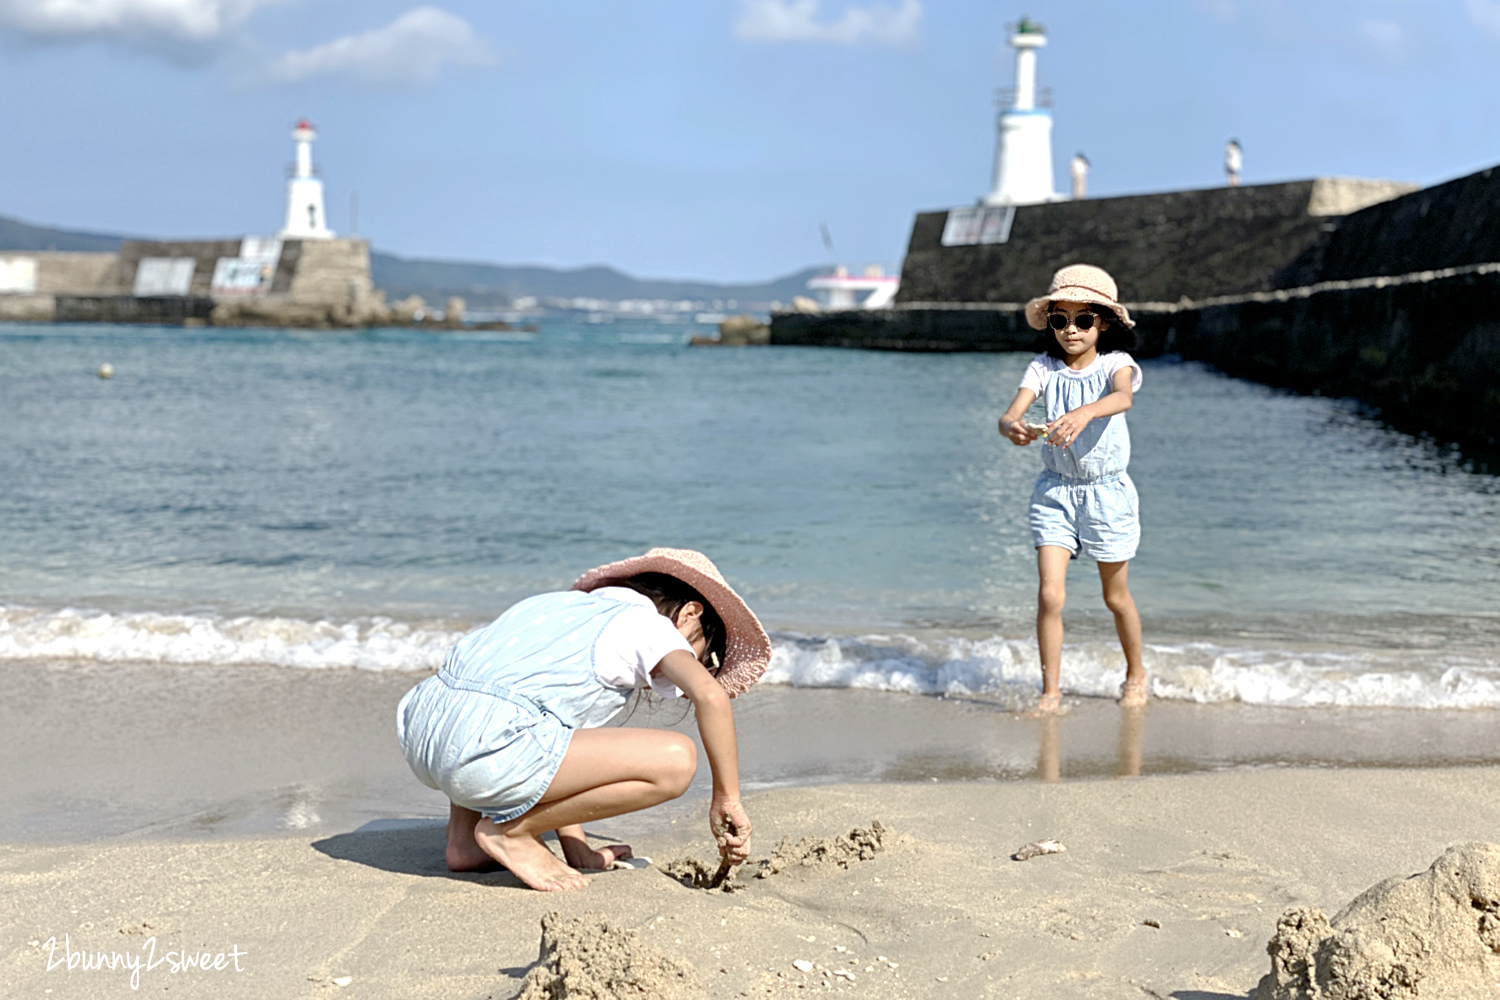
[396,591,632,823]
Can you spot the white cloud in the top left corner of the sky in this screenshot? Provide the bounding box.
[0,0,276,48]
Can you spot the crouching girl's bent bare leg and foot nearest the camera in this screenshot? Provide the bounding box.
[474,729,698,891]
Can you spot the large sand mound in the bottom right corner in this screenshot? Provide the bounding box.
[1256,844,1500,1000]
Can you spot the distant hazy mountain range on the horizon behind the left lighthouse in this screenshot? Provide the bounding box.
[0,216,830,309]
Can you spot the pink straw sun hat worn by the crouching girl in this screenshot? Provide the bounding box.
[573,549,771,697]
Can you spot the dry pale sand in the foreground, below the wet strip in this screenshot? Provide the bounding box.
[0,768,1500,1000]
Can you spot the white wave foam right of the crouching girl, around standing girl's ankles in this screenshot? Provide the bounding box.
[762,636,1500,709]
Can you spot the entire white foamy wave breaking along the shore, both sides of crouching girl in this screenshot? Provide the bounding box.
[0,606,1500,709]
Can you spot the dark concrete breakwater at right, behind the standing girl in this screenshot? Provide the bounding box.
[771,169,1500,460]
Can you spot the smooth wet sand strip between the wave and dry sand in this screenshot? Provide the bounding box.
[0,663,1500,843]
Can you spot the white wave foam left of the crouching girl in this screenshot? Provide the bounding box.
[0,607,464,670]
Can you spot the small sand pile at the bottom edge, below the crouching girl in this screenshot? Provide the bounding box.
[518,912,708,1000]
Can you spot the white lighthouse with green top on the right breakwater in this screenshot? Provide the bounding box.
[984,18,1058,205]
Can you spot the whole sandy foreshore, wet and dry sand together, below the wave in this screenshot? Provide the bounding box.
[0,664,1500,1000]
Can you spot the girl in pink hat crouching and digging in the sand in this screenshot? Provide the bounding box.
[396,549,771,891]
